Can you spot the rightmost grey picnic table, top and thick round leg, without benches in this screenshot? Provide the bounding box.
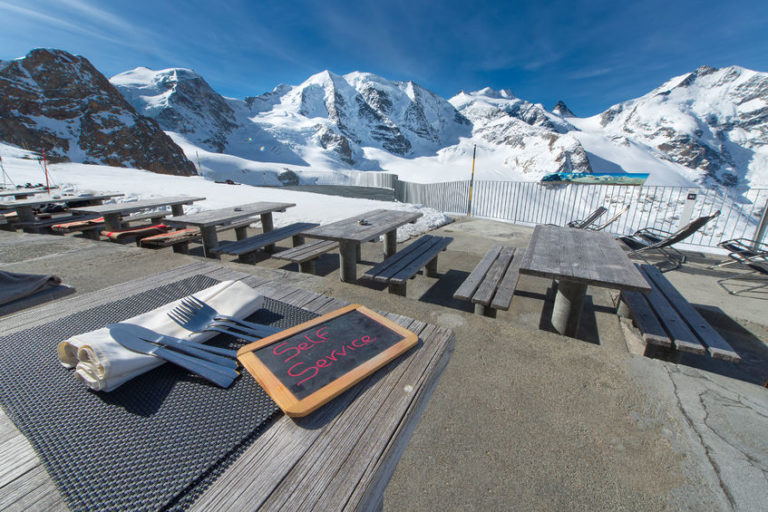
[520,225,651,337]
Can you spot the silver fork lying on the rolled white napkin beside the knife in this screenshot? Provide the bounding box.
[168,297,280,341]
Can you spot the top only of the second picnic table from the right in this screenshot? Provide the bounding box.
[303,210,422,243]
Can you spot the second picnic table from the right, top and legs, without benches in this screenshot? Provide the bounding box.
[304,210,421,283]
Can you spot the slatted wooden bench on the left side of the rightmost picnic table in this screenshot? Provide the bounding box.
[453,245,523,318]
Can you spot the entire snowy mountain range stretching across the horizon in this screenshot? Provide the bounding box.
[0,50,768,189]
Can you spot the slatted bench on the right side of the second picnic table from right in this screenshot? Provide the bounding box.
[361,235,453,296]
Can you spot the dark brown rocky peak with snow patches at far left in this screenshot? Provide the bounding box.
[0,49,196,176]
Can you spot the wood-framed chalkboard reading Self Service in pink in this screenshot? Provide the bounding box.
[237,304,418,417]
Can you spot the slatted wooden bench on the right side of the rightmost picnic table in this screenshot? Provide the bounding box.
[618,265,741,363]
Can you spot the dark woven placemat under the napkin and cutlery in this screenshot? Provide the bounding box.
[0,276,317,510]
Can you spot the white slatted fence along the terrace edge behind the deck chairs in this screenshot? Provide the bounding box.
[395,181,768,247]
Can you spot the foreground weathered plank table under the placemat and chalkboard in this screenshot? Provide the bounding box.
[0,263,455,511]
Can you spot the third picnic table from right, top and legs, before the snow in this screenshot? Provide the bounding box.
[166,201,296,258]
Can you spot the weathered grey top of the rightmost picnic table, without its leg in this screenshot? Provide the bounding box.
[520,225,651,293]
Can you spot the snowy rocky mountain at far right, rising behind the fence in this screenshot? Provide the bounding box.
[592,66,768,187]
